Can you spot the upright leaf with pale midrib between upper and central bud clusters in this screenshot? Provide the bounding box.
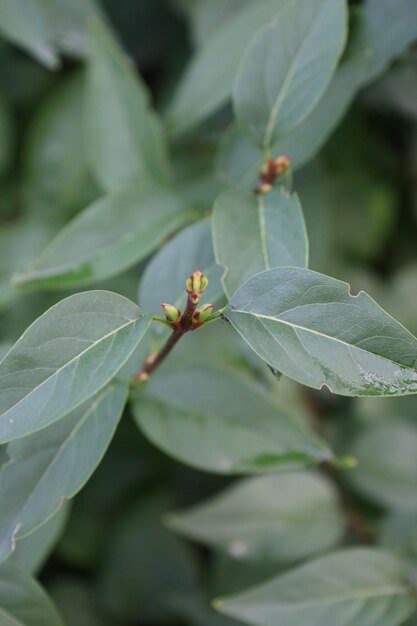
[213,188,308,295]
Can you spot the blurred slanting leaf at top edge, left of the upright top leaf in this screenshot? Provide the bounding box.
[167,0,291,135]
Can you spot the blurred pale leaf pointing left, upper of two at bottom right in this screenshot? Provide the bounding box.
[166,473,344,562]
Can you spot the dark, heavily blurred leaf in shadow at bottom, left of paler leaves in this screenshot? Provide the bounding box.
[97,494,197,624]
